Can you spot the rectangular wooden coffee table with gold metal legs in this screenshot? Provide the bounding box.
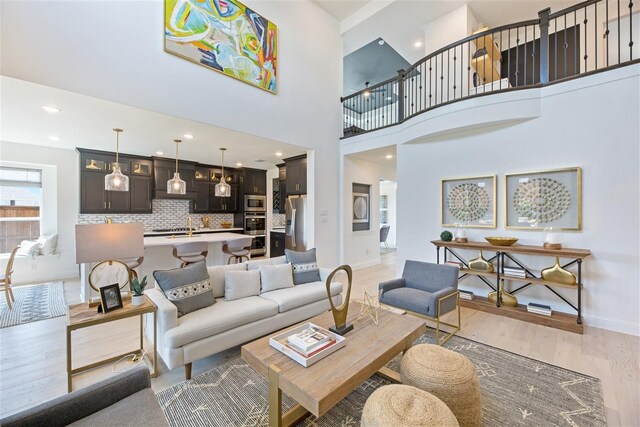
[242,302,426,426]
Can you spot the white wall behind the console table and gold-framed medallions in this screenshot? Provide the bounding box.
[390,65,640,335]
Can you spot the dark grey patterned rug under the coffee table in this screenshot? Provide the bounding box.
[158,331,606,427]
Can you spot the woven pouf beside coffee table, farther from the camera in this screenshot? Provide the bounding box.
[400,344,482,427]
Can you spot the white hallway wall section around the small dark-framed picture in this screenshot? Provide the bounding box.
[342,156,380,270]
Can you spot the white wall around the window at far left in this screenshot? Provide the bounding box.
[0,141,79,284]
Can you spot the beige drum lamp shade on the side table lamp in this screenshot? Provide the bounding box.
[76,222,144,264]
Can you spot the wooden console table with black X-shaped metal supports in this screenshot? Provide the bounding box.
[431,240,591,334]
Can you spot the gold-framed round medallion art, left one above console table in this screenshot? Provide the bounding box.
[440,175,496,228]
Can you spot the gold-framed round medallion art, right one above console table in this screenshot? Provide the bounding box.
[504,167,582,231]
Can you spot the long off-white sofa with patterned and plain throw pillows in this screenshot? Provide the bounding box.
[145,256,342,379]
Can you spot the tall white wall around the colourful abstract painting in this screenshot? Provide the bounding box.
[0,0,342,265]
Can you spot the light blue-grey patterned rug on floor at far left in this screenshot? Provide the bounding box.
[0,282,67,328]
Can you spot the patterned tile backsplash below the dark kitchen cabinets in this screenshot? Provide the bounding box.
[76,199,235,231]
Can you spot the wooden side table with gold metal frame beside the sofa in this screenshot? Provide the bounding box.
[67,296,158,393]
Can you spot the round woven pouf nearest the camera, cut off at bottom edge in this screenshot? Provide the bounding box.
[360,384,458,427]
